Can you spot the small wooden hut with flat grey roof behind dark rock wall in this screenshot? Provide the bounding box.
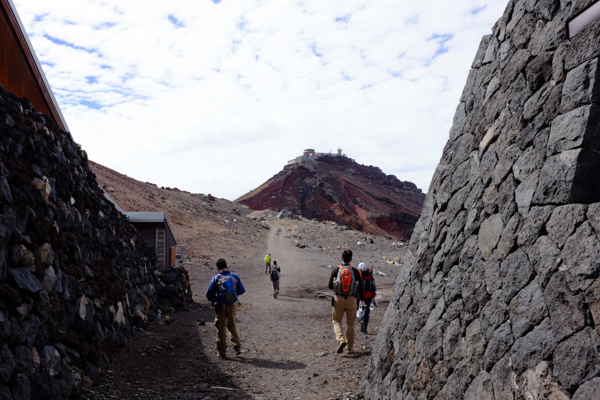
[124,211,177,271]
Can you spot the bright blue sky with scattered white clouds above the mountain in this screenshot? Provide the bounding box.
[13,0,506,200]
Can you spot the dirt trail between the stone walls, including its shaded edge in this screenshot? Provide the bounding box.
[83,222,389,400]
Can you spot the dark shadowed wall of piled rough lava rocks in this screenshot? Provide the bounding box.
[0,86,191,400]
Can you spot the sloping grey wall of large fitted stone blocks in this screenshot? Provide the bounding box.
[360,0,600,400]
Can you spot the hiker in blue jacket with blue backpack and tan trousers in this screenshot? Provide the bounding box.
[206,258,246,360]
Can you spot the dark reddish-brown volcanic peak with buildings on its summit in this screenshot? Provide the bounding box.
[236,155,425,239]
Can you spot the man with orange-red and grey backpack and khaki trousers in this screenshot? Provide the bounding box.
[329,249,363,354]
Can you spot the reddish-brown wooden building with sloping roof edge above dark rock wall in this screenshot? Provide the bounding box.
[0,0,69,132]
